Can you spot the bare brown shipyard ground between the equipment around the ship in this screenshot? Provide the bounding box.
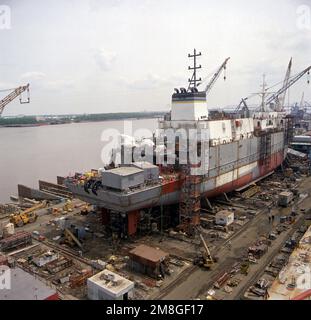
[3,170,311,300]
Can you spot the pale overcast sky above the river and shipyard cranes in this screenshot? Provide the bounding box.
[0,0,311,115]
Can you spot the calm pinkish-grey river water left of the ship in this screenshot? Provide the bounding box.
[0,119,157,203]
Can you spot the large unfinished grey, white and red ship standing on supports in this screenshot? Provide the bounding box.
[66,51,311,235]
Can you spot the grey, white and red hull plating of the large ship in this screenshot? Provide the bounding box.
[67,131,287,213]
